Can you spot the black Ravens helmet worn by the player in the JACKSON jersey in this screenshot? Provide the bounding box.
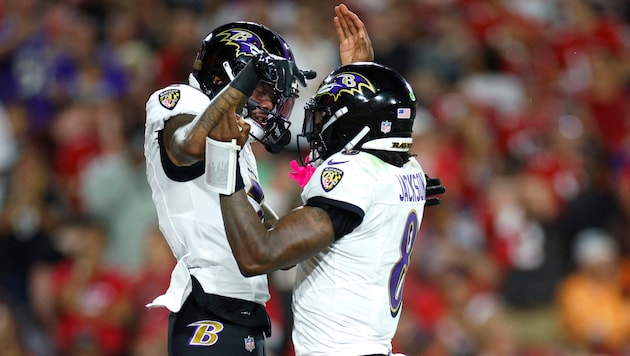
[298,62,416,162]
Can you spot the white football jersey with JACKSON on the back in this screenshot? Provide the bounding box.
[293,152,426,356]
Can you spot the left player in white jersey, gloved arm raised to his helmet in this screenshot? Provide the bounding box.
[144,5,373,356]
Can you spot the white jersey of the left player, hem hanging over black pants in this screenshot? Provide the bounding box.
[144,84,269,312]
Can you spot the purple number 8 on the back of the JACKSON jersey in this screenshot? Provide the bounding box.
[389,210,418,318]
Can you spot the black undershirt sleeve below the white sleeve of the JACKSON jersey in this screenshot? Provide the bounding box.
[304,197,365,241]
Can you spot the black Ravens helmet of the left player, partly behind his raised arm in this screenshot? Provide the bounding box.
[189,21,298,153]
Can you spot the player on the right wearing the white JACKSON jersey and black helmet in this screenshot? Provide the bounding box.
[220,62,443,356]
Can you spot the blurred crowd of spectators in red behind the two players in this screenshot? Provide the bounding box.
[0,0,630,356]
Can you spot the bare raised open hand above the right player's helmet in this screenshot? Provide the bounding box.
[333,4,374,65]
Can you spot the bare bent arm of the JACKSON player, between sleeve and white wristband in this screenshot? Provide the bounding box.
[221,191,334,276]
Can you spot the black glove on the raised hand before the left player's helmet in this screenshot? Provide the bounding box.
[253,52,315,98]
